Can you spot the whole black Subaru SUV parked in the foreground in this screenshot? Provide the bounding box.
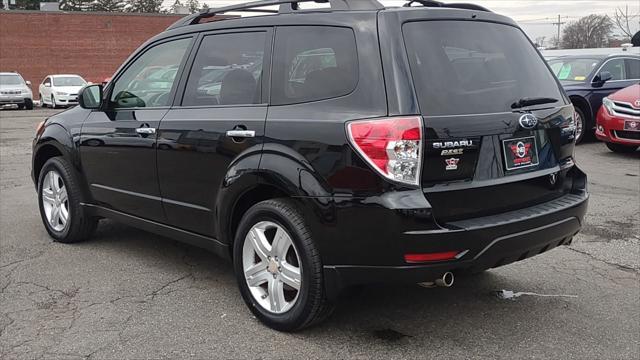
[33,0,588,331]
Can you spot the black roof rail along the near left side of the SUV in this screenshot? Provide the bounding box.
[167,0,384,30]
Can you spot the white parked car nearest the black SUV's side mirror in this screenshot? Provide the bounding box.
[39,75,87,109]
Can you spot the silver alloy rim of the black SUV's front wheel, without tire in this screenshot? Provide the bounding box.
[42,170,69,231]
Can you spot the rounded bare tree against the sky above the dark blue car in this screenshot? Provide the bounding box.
[562,14,613,49]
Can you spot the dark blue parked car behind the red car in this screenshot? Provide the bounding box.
[549,54,640,142]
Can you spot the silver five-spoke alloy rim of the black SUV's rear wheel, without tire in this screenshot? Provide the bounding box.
[242,221,302,314]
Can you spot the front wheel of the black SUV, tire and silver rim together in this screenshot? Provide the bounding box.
[38,157,98,243]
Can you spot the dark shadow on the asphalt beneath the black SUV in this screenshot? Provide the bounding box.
[74,220,568,345]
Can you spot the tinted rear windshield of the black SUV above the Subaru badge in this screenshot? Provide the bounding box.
[403,21,562,116]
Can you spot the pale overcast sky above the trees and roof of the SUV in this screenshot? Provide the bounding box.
[175,0,640,40]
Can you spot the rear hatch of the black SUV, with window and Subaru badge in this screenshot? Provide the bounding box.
[402,18,574,222]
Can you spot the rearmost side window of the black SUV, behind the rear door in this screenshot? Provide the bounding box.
[271,26,358,105]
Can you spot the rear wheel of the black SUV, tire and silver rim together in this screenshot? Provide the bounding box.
[233,199,333,331]
